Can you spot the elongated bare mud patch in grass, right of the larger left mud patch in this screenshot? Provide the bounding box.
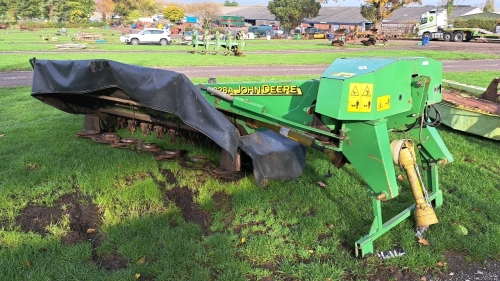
[167,187,212,234]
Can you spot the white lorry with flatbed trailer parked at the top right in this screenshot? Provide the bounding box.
[418,9,500,42]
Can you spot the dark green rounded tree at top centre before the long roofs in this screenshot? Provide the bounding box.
[267,0,321,33]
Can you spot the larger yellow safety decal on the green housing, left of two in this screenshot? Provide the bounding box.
[347,83,373,112]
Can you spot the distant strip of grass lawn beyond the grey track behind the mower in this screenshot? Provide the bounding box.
[0,29,498,71]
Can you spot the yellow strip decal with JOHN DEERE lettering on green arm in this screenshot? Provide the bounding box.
[214,84,302,96]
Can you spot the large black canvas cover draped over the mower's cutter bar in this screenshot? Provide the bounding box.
[31,59,238,160]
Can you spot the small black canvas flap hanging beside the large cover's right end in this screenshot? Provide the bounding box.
[240,130,306,187]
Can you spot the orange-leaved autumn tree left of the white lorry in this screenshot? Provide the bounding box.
[361,0,422,29]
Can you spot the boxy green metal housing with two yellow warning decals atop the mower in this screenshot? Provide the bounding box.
[316,58,442,120]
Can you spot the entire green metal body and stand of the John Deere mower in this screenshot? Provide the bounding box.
[200,58,453,255]
